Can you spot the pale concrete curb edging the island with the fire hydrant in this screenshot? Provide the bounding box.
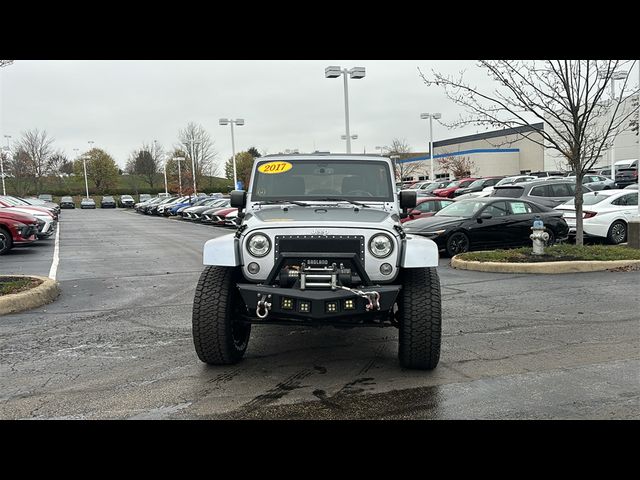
[451,256,640,274]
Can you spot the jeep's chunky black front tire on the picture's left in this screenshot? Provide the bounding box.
[192,266,251,365]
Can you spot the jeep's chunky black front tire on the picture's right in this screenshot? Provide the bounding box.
[396,267,442,370]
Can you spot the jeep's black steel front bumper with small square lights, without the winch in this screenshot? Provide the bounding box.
[237,283,402,323]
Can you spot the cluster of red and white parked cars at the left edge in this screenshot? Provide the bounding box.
[0,195,60,255]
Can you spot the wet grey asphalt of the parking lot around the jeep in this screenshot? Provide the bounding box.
[0,209,640,419]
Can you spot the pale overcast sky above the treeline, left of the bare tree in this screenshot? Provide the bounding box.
[0,60,528,172]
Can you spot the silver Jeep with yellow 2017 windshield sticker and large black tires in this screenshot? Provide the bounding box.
[193,154,441,369]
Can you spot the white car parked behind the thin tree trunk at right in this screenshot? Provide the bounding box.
[556,190,638,245]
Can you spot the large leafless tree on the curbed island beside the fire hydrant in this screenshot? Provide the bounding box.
[418,60,637,245]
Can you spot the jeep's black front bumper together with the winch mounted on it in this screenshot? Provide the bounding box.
[237,255,401,322]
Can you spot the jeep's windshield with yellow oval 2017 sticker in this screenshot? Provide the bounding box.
[250,159,393,202]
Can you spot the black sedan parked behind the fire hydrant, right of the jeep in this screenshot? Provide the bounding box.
[404,197,569,256]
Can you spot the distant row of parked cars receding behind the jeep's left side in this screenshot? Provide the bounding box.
[134,193,238,227]
